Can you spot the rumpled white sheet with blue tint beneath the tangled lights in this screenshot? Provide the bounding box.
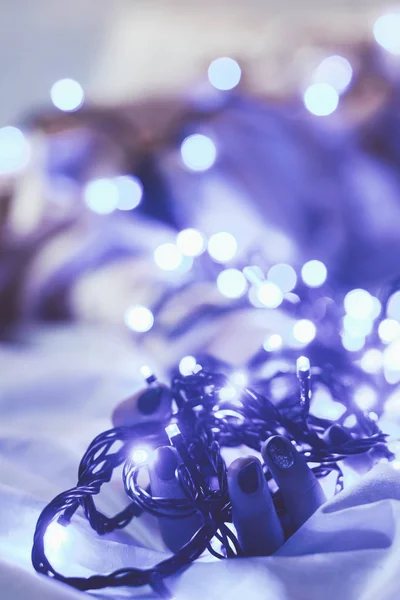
[0,328,400,600]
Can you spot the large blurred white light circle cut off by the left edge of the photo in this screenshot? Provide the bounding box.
[0,127,30,175]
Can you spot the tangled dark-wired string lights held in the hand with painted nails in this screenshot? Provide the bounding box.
[32,344,391,597]
